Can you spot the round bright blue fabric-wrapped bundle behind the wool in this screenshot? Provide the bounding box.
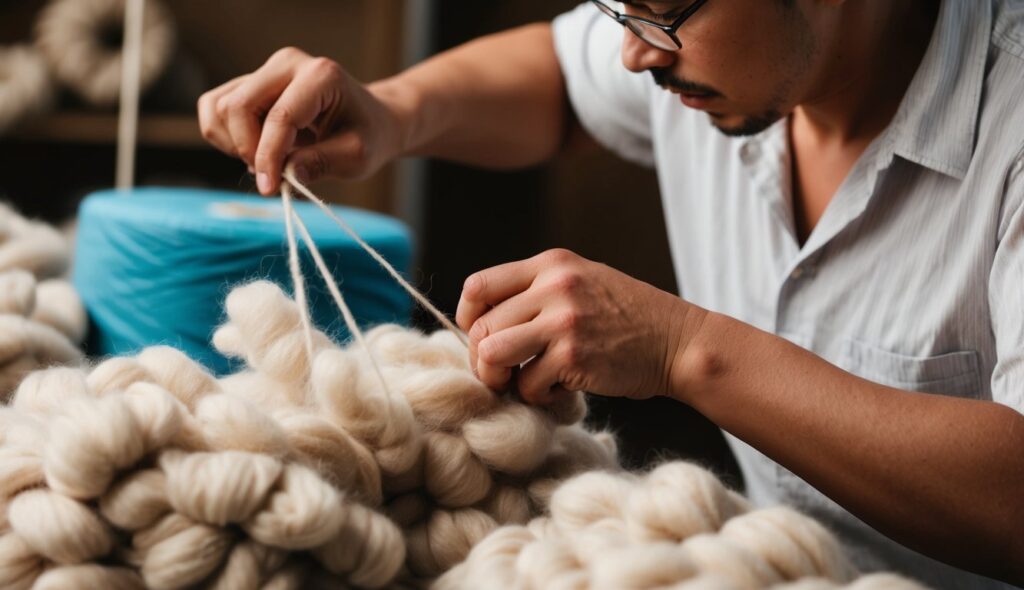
[74,187,412,373]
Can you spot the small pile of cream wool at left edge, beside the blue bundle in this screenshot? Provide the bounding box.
[0,204,87,399]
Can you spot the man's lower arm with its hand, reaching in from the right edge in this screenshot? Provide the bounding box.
[456,248,1024,585]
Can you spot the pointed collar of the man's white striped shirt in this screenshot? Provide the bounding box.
[886,0,992,179]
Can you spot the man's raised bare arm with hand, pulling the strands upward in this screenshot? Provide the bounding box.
[198,24,579,195]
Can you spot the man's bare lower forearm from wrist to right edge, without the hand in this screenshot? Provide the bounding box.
[673,313,1024,585]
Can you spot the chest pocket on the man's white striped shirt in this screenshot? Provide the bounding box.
[837,340,983,398]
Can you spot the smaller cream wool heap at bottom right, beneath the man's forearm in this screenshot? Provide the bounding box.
[434,462,922,590]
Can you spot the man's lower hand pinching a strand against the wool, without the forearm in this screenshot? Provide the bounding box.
[456,250,706,404]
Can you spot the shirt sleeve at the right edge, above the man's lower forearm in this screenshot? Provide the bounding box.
[988,149,1024,413]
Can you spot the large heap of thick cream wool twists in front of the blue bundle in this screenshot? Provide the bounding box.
[0,282,616,589]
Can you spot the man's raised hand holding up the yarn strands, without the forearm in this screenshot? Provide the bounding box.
[199,48,404,195]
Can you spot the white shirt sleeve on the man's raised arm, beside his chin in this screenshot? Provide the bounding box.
[553,2,654,166]
